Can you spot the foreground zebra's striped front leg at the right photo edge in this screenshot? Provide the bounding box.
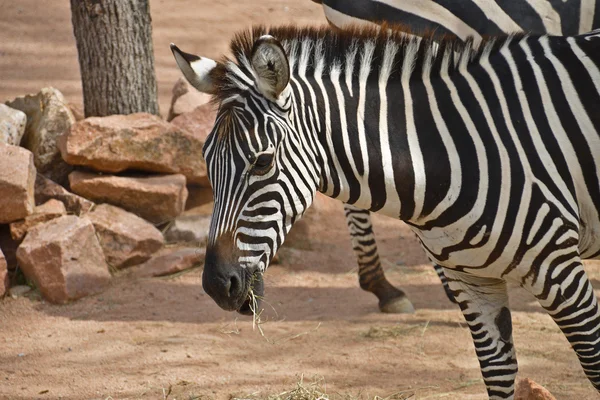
[525,259,600,392]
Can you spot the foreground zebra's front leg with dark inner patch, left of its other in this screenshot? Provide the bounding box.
[444,268,517,399]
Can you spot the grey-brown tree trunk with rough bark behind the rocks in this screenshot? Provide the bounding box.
[71,0,159,117]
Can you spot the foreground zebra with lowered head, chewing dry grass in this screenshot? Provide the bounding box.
[172,27,600,399]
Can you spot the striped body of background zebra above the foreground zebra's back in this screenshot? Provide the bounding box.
[313,0,600,38]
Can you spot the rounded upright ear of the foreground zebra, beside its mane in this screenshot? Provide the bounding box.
[250,35,290,100]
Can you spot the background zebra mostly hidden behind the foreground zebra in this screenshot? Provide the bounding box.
[312,0,600,312]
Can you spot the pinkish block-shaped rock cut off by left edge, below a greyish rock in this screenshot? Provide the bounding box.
[0,143,35,224]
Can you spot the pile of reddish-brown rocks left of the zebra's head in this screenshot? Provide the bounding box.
[0,86,214,303]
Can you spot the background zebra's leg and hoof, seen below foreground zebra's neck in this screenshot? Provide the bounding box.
[344,204,415,314]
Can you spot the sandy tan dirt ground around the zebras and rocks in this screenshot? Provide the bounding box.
[0,0,600,400]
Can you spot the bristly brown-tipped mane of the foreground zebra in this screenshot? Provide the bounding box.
[211,24,523,105]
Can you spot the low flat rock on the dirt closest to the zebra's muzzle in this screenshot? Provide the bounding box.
[132,248,205,278]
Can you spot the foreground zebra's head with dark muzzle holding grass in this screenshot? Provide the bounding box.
[171,35,317,314]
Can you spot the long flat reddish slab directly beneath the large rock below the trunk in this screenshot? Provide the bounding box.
[69,171,188,224]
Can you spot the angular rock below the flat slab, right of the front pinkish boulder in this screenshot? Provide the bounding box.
[85,204,164,268]
